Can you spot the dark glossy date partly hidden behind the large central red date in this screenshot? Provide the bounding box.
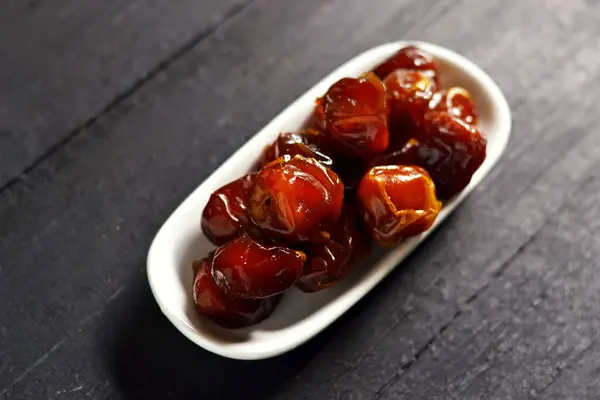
[257,129,333,169]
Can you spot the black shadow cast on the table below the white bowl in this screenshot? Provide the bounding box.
[96,274,343,399]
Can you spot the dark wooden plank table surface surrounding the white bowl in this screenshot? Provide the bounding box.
[0,0,600,400]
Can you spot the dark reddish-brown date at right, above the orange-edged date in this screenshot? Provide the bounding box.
[417,111,486,199]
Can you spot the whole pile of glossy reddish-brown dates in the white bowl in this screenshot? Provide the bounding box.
[193,46,486,328]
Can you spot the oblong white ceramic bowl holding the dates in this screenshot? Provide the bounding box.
[148,41,511,360]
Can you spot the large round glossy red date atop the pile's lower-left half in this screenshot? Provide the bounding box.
[250,155,344,242]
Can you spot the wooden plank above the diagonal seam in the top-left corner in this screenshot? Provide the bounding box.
[0,0,250,188]
